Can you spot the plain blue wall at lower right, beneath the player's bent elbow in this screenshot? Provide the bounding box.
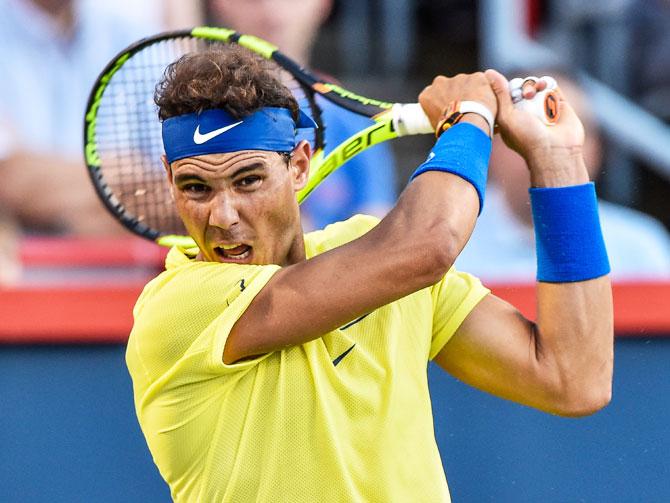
[429,339,670,503]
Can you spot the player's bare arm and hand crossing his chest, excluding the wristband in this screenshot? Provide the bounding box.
[223,74,496,363]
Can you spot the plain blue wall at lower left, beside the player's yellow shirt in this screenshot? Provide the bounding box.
[0,346,170,503]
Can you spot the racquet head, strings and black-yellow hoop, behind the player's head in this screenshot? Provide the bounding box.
[84,29,325,244]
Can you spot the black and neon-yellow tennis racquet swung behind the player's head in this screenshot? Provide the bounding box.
[84,27,556,247]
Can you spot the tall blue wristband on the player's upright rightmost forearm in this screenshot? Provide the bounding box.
[529,182,610,283]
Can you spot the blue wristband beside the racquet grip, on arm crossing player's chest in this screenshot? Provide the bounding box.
[410,122,491,214]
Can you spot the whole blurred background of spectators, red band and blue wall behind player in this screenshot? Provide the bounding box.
[0,0,670,503]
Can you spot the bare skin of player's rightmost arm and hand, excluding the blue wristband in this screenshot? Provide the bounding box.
[436,71,613,416]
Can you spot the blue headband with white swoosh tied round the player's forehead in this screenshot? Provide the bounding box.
[163,107,318,163]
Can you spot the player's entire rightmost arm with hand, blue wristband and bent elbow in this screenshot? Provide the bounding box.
[436,70,613,416]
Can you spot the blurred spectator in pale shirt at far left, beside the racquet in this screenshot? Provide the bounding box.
[0,0,163,235]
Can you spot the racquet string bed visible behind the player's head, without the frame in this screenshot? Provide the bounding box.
[95,36,323,239]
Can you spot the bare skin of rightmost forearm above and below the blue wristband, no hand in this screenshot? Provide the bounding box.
[529,151,613,415]
